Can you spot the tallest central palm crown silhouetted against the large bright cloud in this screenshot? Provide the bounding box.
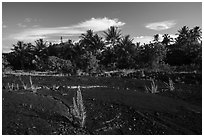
[104,26,121,47]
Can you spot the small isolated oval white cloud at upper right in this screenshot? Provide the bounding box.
[145,20,176,31]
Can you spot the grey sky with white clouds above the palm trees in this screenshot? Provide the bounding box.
[2,2,202,52]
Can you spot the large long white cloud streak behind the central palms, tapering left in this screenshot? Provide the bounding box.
[10,17,125,40]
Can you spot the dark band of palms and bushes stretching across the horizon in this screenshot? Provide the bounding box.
[3,26,202,74]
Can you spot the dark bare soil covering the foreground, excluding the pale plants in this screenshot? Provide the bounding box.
[2,75,202,135]
